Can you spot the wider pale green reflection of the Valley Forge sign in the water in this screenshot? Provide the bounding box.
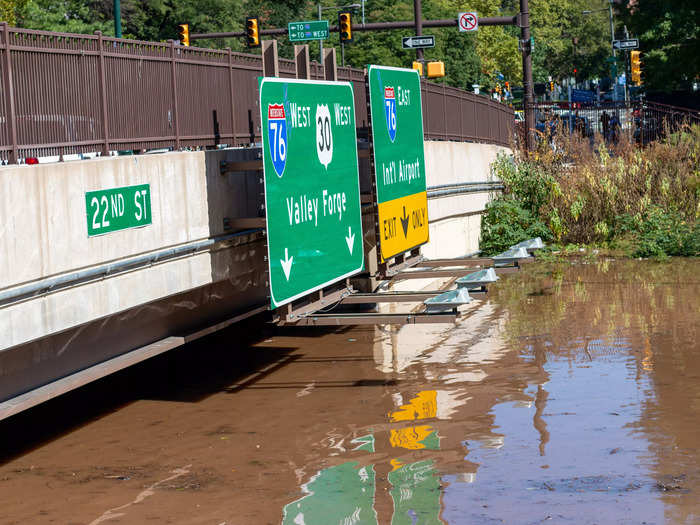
[282,461,378,525]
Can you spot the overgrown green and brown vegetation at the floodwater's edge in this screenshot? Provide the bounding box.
[481,126,700,257]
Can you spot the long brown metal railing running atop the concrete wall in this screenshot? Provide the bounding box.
[0,23,513,163]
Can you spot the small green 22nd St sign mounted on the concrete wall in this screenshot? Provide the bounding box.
[85,184,151,237]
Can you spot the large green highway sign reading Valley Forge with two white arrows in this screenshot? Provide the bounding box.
[260,78,364,308]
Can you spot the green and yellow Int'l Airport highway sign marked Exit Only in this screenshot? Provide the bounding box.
[367,66,428,262]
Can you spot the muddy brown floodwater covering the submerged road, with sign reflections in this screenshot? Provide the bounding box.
[0,260,700,525]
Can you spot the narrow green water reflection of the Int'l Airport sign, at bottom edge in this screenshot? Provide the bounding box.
[389,460,443,525]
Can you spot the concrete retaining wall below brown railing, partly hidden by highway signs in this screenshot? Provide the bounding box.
[0,138,506,401]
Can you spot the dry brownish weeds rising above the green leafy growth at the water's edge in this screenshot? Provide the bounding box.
[504,126,700,243]
